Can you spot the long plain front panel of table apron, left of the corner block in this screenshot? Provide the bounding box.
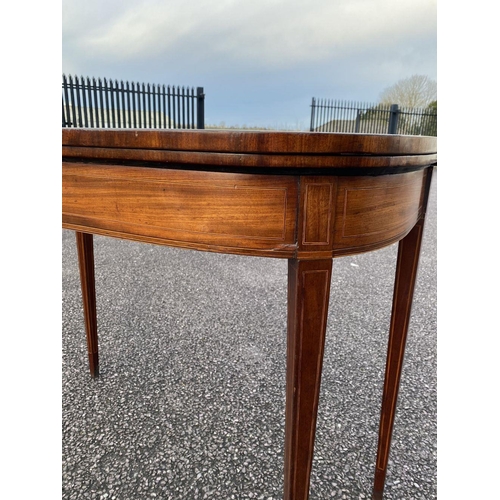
[63,163,297,256]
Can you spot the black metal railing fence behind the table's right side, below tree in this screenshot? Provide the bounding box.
[310,97,437,136]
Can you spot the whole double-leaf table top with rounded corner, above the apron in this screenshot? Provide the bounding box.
[62,128,437,169]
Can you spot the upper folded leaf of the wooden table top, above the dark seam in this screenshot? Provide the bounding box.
[62,128,437,156]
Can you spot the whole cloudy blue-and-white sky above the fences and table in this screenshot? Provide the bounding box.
[62,0,437,129]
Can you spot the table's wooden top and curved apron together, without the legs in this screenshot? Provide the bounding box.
[63,129,436,258]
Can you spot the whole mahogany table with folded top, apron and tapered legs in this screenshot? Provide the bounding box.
[62,129,437,500]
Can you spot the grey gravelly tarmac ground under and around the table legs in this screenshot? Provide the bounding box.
[62,173,437,500]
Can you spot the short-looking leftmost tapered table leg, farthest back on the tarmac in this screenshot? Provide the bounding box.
[76,231,99,377]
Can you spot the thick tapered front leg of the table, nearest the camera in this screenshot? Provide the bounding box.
[284,259,332,500]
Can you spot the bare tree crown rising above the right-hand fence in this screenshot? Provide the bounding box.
[380,75,437,108]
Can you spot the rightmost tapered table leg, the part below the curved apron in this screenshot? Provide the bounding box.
[373,219,424,500]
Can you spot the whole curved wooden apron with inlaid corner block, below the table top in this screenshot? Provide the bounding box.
[62,162,426,259]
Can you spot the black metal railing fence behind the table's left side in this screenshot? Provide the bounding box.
[62,75,205,129]
